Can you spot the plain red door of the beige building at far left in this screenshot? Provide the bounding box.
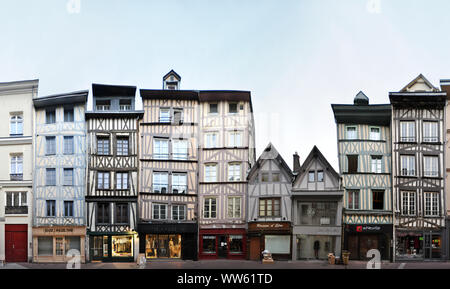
[5,225,28,262]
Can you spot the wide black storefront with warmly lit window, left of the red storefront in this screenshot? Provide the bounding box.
[138,224,198,260]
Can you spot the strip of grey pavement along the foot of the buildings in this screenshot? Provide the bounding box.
[0,260,450,270]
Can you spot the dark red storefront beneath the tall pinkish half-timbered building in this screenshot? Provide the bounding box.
[199,229,247,260]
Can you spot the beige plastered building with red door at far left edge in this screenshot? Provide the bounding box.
[0,80,39,262]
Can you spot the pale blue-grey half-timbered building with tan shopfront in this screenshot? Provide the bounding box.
[33,91,88,263]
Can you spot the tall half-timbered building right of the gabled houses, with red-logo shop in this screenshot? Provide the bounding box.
[332,92,393,260]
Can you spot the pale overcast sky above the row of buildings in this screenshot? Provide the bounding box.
[0,0,450,170]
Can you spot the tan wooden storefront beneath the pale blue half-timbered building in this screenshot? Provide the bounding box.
[32,226,86,263]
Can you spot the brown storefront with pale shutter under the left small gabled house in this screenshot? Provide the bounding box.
[248,222,292,260]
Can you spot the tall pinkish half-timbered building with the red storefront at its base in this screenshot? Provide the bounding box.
[199,91,256,259]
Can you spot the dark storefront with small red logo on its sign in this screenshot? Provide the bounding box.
[344,225,393,260]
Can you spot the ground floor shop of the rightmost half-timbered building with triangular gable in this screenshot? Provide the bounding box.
[395,229,445,261]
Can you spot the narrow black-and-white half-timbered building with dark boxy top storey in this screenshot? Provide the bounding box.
[86,84,143,261]
